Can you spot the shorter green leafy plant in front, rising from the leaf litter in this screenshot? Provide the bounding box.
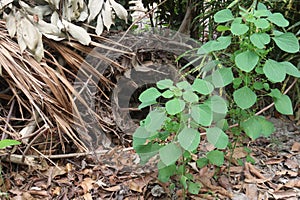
[133,79,228,193]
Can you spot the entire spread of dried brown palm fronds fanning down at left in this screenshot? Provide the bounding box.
[0,21,132,153]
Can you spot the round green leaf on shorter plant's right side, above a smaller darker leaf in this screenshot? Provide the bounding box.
[206,127,228,149]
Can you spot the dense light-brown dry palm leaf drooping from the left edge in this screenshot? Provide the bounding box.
[0,22,87,151]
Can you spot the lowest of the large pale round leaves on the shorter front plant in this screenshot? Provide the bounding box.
[159,143,182,166]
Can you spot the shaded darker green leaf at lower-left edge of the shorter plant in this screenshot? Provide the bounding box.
[134,143,162,165]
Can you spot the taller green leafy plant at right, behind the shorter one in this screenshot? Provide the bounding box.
[198,3,300,139]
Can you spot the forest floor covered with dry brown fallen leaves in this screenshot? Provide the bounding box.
[0,118,300,200]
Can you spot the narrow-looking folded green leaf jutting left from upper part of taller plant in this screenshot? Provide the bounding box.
[197,36,231,54]
